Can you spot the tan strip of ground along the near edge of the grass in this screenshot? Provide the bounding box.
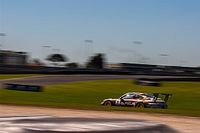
[0,105,200,133]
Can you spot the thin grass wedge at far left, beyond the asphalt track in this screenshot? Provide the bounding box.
[0,74,44,80]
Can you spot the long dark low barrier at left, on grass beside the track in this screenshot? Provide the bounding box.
[3,83,43,92]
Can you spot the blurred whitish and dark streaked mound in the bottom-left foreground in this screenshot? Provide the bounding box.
[0,116,177,133]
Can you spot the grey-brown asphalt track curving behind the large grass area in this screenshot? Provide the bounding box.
[0,75,198,85]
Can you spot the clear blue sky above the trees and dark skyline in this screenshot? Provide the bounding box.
[0,0,200,66]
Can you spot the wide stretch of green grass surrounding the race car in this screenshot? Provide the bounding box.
[0,80,200,116]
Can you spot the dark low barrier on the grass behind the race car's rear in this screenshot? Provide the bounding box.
[134,79,161,87]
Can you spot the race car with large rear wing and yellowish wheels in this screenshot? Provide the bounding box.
[101,92,172,109]
